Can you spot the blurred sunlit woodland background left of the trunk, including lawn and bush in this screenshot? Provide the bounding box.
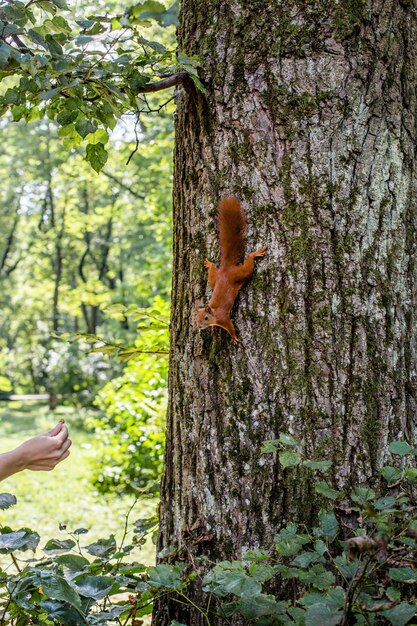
[0,3,175,538]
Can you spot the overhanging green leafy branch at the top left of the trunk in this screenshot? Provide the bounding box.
[0,0,202,172]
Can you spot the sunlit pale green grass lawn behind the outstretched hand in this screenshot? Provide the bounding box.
[0,402,156,564]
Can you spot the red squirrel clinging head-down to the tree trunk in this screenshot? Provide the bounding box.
[196,196,266,344]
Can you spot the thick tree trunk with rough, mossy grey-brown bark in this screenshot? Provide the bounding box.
[154,0,417,626]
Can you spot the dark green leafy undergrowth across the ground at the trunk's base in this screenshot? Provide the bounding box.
[0,435,417,626]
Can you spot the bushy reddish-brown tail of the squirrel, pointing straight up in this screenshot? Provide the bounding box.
[219,196,246,267]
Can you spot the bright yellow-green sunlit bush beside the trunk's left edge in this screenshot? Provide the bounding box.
[90,297,169,493]
